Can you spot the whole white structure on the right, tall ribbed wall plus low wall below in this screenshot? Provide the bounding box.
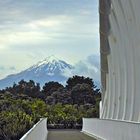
[83,0,140,140]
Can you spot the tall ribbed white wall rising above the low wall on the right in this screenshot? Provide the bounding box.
[100,0,140,122]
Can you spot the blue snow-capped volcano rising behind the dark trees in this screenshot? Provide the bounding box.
[0,56,73,89]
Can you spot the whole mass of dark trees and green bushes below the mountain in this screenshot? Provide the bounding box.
[0,76,101,140]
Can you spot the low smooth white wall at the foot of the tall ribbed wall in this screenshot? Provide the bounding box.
[82,119,140,140]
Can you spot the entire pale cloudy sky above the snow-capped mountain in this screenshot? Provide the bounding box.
[0,0,99,79]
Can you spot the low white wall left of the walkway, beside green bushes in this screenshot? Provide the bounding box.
[20,118,48,140]
